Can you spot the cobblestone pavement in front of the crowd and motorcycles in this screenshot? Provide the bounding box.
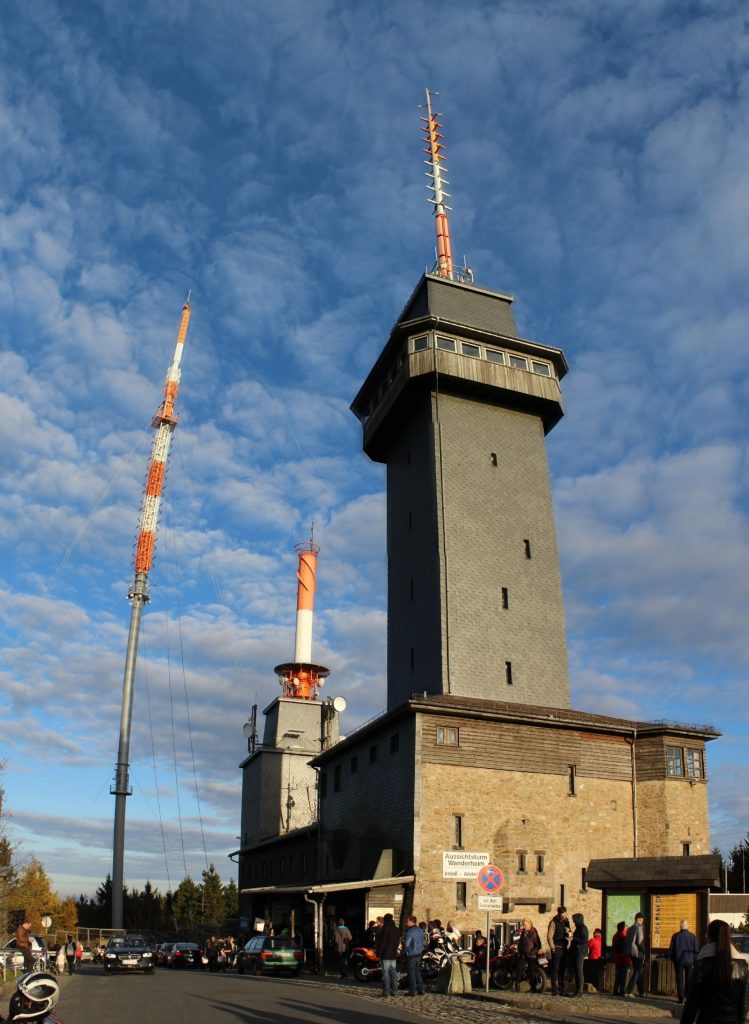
[321,977,681,1024]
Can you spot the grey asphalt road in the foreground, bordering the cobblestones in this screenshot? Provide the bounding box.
[58,965,672,1024]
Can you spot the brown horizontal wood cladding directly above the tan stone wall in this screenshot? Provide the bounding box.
[422,717,631,779]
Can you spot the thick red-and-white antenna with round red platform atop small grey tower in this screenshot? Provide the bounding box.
[274,537,330,700]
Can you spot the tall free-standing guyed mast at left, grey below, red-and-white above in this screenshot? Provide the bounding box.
[110,296,191,928]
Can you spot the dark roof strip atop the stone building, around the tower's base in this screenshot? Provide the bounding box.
[309,693,720,766]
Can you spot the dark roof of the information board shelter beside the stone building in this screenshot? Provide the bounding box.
[585,853,721,892]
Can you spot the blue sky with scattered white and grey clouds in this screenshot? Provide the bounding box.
[0,0,749,894]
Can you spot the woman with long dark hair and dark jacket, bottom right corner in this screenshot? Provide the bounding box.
[681,921,749,1024]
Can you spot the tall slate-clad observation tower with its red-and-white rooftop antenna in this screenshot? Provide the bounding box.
[351,91,570,708]
